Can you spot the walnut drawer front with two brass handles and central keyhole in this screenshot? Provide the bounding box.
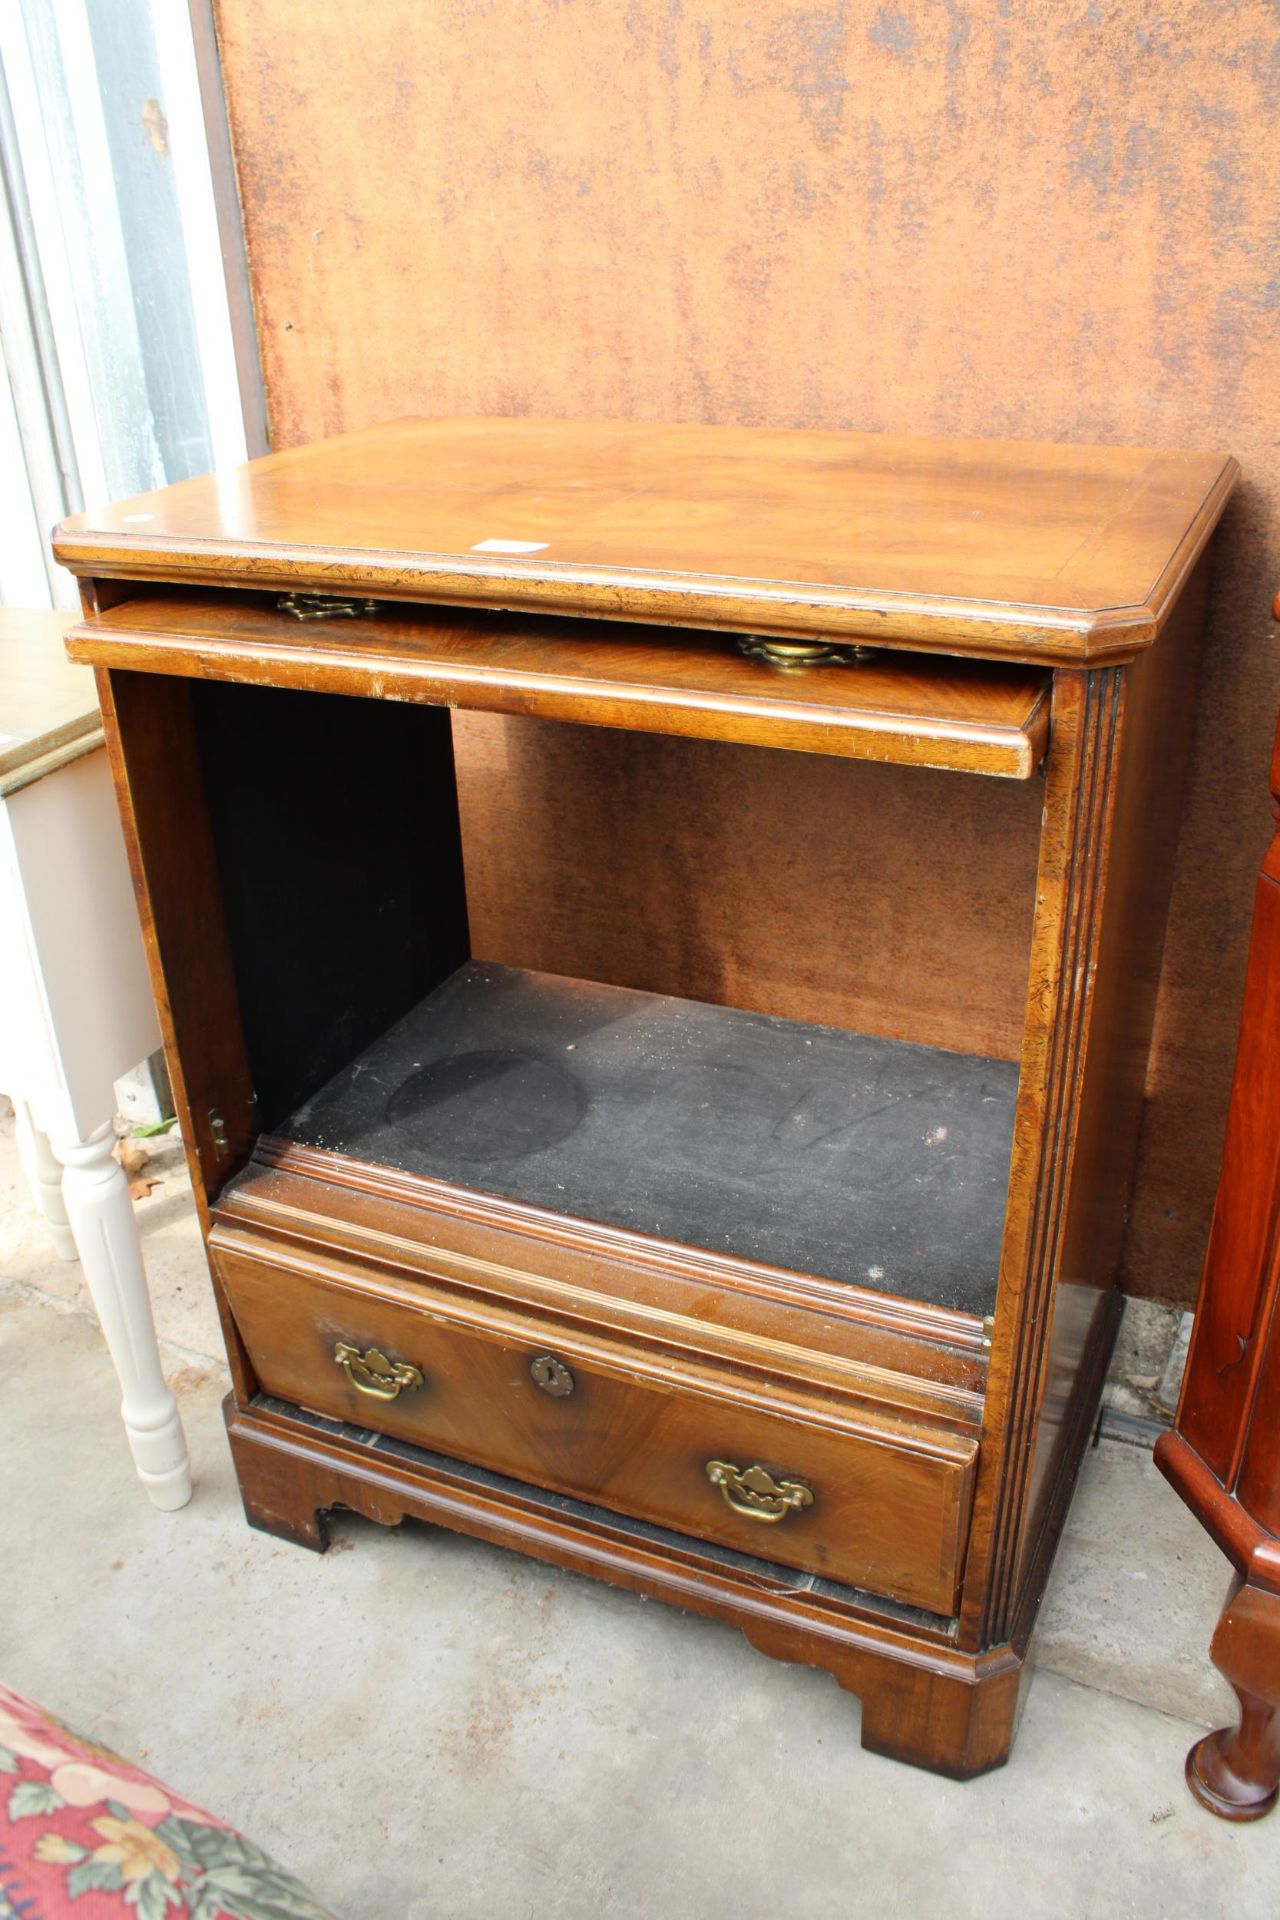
[211,1229,977,1615]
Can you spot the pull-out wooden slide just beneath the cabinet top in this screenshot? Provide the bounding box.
[67,593,1050,780]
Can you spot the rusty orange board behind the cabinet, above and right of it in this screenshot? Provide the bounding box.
[219,0,1280,1298]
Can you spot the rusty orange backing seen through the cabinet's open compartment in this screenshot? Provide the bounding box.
[455,714,1044,1060]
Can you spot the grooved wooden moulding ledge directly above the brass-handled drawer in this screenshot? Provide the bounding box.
[217,1137,986,1434]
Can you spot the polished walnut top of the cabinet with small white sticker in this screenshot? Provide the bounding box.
[54,419,1238,659]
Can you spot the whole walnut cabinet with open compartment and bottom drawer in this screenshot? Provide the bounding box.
[56,420,1236,1778]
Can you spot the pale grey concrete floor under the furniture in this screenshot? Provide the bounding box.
[0,1102,1280,1920]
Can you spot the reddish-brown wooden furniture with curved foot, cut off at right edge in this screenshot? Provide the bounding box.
[1155,599,1280,1820]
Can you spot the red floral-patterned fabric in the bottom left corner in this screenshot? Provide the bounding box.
[0,1686,334,1920]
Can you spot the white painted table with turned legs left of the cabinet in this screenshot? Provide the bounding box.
[0,607,192,1507]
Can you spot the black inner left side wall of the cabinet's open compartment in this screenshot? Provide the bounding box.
[192,682,468,1129]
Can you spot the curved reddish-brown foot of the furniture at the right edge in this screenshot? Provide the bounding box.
[1186,1580,1280,1820]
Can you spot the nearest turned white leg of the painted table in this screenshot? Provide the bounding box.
[54,1125,192,1509]
